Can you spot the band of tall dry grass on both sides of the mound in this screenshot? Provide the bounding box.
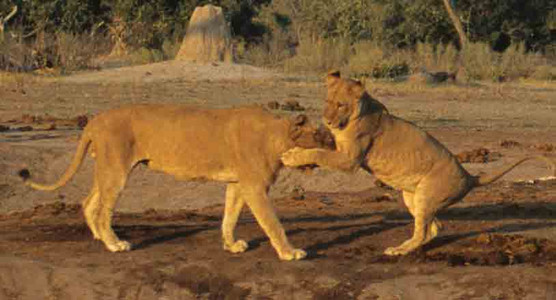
[0,32,556,84]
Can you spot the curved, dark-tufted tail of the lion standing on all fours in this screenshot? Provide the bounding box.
[19,129,91,191]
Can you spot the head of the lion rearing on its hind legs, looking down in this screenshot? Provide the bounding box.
[323,71,387,131]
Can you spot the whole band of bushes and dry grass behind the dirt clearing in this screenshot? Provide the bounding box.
[0,0,556,80]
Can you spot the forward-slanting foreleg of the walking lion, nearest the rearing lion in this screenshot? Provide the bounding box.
[241,187,307,260]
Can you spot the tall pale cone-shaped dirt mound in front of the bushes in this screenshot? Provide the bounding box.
[176,4,233,62]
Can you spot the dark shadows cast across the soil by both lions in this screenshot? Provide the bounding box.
[115,202,556,254]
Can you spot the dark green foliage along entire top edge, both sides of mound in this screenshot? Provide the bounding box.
[0,0,556,51]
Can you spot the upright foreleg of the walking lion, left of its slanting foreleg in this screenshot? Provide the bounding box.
[222,183,248,253]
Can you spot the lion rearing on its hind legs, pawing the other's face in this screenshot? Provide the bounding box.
[282,71,556,255]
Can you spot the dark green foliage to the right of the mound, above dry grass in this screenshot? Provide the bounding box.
[259,0,556,51]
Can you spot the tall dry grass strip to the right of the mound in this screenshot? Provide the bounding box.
[244,37,556,82]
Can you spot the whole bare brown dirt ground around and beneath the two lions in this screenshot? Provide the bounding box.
[0,62,556,299]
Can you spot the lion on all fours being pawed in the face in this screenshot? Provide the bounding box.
[19,105,332,260]
